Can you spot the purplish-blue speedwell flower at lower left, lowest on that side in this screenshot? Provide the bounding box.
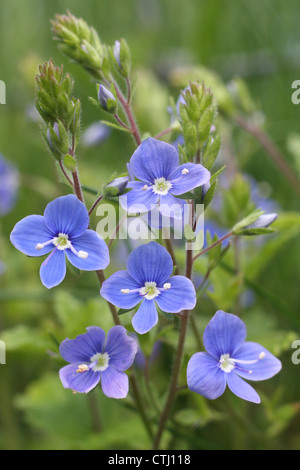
[59,325,138,398]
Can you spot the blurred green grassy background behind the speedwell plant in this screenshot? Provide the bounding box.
[0,0,300,449]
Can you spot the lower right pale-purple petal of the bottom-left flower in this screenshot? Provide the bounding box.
[101,367,129,398]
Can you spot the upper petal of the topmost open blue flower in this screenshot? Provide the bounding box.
[130,137,179,184]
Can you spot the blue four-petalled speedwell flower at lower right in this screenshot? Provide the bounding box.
[187,310,281,403]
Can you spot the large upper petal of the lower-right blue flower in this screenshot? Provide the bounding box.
[203,310,246,359]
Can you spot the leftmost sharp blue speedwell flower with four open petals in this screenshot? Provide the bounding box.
[10,194,109,289]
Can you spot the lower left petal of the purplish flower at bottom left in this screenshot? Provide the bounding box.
[59,363,100,393]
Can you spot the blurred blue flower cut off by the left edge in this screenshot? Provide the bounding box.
[0,154,19,216]
